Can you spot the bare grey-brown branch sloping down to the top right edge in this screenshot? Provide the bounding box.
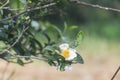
[70,0,120,13]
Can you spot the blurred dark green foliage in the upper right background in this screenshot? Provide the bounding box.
[42,0,120,40]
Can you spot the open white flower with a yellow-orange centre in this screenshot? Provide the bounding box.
[59,43,77,60]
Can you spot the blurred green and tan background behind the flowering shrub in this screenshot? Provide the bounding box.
[0,0,120,80]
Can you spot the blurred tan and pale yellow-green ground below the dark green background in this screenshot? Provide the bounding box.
[0,38,120,80]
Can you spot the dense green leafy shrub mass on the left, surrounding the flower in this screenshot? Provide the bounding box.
[0,0,83,71]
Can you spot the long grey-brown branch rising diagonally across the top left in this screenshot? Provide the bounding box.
[0,3,56,22]
